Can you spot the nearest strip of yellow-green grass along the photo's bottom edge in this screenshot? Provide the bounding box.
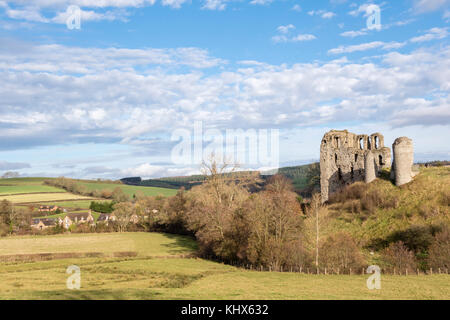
[0,258,450,300]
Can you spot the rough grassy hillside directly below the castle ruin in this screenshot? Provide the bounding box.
[324,167,450,262]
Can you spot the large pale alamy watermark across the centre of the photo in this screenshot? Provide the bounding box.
[171,121,280,174]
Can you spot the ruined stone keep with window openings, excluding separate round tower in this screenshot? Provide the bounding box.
[320,130,391,202]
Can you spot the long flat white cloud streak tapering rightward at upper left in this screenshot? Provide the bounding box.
[0,40,226,74]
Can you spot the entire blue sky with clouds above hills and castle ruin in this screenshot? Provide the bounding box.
[0,0,450,179]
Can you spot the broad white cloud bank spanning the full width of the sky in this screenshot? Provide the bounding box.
[0,43,450,162]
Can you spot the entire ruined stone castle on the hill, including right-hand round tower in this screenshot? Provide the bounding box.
[320,130,414,202]
